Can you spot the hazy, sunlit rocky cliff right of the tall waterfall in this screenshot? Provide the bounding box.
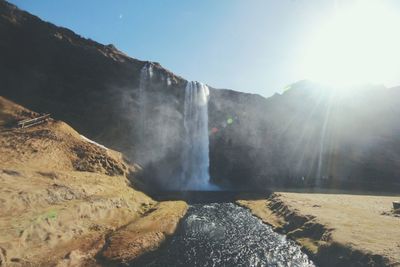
[210,81,400,190]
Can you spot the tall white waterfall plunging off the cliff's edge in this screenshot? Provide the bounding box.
[181,82,210,190]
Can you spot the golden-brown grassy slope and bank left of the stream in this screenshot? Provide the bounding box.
[0,97,187,266]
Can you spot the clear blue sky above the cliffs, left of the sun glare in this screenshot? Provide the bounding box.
[10,0,400,96]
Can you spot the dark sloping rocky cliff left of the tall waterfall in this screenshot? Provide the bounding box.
[0,1,186,188]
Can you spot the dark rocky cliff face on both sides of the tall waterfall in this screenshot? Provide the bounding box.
[0,1,400,192]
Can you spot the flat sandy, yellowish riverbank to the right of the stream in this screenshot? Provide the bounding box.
[238,192,400,266]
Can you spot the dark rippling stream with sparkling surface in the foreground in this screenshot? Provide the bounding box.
[131,203,314,267]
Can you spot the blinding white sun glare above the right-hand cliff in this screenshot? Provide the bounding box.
[301,0,400,87]
